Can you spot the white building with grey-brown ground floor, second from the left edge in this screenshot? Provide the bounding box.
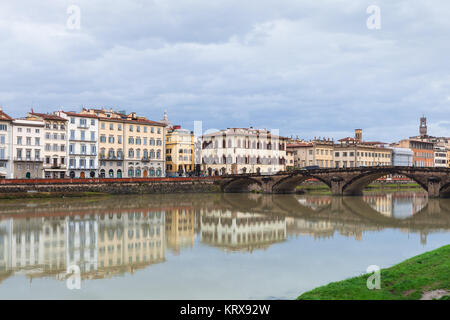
[12,119,44,179]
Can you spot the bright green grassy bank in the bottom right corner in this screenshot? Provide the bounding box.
[297,245,450,300]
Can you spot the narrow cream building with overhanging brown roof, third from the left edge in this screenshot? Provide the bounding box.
[27,112,67,179]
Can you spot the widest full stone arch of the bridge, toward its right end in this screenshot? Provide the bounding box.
[342,168,428,195]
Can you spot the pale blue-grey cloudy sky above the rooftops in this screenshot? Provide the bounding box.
[0,0,450,142]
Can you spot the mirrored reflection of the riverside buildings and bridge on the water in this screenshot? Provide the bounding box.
[0,192,450,282]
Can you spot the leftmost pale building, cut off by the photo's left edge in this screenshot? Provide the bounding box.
[0,107,13,179]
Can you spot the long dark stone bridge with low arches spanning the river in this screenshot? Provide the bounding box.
[221,167,450,198]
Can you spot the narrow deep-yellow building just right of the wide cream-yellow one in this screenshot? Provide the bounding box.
[160,112,195,177]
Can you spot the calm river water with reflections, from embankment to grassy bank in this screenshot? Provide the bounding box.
[0,192,450,299]
